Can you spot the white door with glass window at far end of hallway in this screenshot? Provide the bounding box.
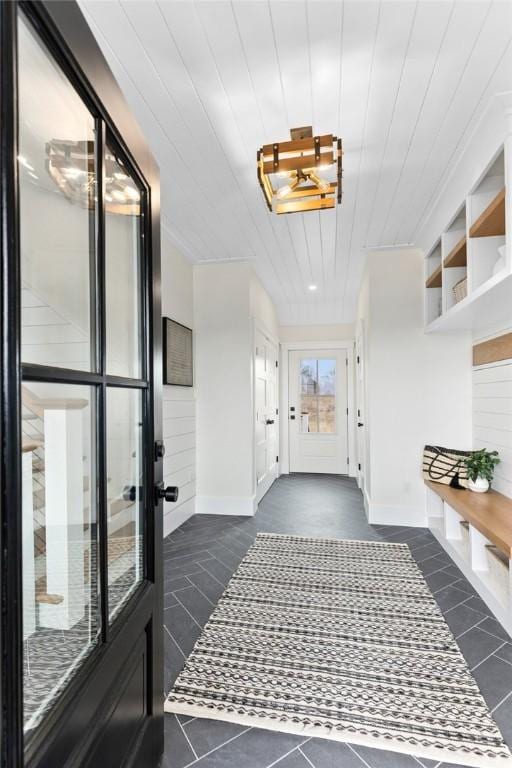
[288,349,348,475]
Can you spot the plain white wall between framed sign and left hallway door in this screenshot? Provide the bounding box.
[194,262,278,515]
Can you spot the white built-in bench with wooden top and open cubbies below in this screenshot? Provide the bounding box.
[425,480,512,634]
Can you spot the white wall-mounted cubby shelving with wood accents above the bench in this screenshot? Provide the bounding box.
[425,148,512,332]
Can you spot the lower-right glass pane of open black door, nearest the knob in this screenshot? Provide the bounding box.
[107,387,144,619]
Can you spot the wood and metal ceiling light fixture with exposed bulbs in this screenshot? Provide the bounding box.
[257,126,343,214]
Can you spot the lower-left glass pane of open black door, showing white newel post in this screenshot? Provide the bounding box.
[21,382,100,732]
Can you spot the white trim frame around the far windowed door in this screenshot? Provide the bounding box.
[279,339,357,477]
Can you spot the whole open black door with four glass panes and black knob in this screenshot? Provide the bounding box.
[0,2,163,768]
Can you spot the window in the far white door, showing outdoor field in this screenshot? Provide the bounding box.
[300,358,336,434]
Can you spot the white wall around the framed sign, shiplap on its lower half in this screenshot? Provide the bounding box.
[162,230,196,536]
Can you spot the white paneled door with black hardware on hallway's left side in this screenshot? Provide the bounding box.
[254,328,279,501]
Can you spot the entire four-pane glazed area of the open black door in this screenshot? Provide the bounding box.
[14,4,152,743]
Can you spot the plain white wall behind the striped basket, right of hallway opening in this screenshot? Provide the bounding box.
[359,249,472,525]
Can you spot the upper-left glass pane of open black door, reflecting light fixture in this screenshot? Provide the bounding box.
[18,12,97,371]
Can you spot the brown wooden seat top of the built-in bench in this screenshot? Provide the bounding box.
[425,480,512,559]
